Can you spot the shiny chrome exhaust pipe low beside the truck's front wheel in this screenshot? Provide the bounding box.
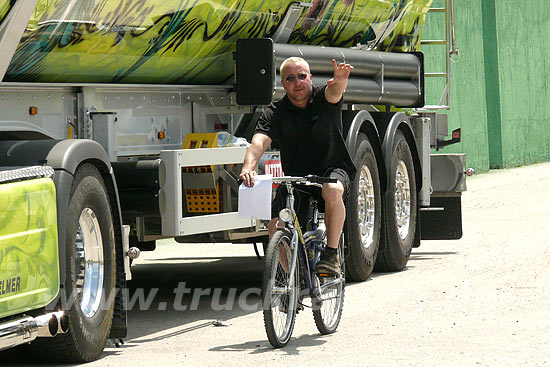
[0,311,69,351]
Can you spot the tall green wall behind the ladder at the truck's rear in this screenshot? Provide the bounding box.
[422,0,550,172]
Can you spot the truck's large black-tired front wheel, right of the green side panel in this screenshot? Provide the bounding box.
[31,164,116,362]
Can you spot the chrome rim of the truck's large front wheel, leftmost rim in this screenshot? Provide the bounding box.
[75,208,104,317]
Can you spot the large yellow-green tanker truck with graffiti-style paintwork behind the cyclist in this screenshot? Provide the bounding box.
[0,0,465,362]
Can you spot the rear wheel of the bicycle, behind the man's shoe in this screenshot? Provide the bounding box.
[311,237,346,335]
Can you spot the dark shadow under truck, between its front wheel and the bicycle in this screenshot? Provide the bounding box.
[122,257,263,344]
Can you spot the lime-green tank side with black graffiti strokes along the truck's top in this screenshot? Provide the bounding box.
[4,0,432,84]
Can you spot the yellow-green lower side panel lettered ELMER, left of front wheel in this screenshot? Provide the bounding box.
[0,178,59,318]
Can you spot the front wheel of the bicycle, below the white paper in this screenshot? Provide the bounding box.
[262,229,300,348]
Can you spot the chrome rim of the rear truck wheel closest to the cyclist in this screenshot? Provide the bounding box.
[357,166,375,249]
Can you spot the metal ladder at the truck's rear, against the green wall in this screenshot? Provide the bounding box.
[420,0,459,110]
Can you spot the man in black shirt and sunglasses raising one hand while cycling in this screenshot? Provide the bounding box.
[240,57,356,274]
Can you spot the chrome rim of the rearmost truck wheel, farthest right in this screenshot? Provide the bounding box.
[395,160,411,240]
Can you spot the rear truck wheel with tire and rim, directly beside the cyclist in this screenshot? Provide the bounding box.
[346,134,382,281]
